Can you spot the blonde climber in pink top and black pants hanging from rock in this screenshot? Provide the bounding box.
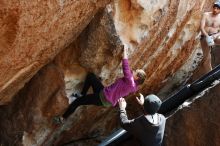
[59,48,146,123]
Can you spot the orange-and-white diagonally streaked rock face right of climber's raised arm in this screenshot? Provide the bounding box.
[116,0,204,92]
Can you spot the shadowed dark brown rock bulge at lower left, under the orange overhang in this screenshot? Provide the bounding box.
[0,64,68,146]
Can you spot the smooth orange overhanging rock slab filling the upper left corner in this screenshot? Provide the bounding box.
[0,0,109,105]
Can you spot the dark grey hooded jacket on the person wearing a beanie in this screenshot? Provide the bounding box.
[120,110,166,146]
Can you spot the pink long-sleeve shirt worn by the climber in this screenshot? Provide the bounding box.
[103,59,137,106]
